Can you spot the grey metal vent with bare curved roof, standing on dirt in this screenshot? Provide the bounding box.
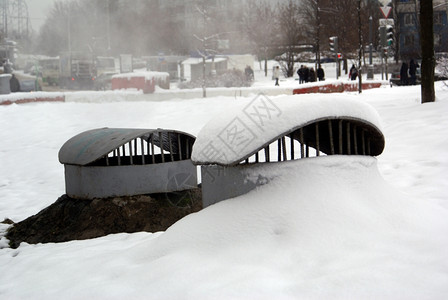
[59,128,197,199]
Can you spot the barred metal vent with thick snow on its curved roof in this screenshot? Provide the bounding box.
[192,95,385,207]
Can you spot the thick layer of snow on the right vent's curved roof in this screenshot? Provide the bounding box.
[192,95,381,165]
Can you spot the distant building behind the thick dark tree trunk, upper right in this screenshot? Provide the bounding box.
[395,0,448,59]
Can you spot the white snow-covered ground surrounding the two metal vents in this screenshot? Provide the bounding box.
[0,65,448,299]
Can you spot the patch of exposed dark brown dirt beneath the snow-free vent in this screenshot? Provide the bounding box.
[6,188,202,248]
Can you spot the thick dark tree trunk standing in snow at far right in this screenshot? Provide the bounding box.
[420,0,436,103]
